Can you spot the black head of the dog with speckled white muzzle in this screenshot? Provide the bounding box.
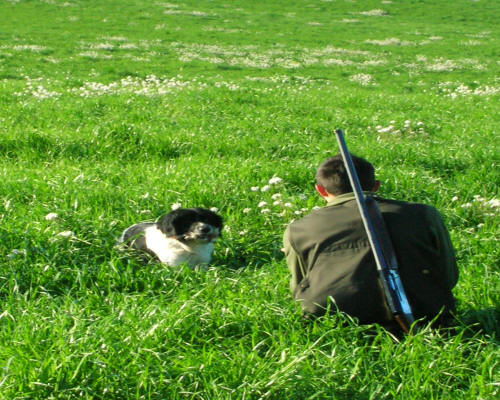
[157,208,222,242]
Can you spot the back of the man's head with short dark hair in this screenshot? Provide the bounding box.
[316,154,375,196]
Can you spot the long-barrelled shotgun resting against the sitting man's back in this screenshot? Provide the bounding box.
[335,129,415,333]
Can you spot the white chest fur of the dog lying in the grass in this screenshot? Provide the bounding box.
[144,226,214,267]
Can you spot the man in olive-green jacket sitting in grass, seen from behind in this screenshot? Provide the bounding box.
[283,155,458,330]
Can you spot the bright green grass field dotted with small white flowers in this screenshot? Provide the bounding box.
[0,0,500,400]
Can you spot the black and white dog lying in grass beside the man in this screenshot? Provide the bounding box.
[118,208,222,268]
